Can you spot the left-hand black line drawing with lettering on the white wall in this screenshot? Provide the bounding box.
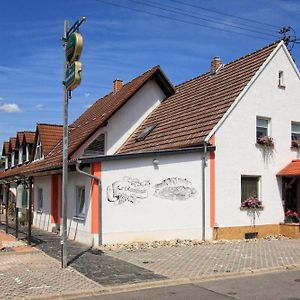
[107,177,150,204]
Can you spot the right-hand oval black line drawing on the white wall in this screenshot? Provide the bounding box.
[153,177,198,200]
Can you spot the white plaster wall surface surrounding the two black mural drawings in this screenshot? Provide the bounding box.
[101,153,211,244]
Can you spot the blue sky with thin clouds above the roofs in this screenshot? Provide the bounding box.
[0,0,300,145]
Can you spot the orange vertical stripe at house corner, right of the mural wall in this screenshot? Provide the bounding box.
[209,135,216,228]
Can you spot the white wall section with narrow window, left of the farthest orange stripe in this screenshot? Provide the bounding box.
[33,176,52,231]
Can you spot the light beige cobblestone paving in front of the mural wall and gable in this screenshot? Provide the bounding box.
[108,239,300,279]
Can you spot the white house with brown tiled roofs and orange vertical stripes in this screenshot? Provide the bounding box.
[0,41,300,245]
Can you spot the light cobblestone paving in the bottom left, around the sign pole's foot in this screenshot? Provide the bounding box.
[0,251,101,299]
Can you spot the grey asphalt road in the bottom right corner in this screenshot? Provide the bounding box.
[74,270,300,300]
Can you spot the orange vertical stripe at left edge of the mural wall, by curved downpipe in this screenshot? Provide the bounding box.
[91,163,101,234]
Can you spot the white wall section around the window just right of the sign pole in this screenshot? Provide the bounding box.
[67,168,93,245]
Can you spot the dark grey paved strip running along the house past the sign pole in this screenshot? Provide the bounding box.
[0,224,165,286]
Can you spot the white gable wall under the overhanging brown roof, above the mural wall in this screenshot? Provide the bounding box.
[106,80,166,155]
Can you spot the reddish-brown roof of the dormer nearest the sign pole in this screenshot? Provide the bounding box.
[36,124,63,156]
